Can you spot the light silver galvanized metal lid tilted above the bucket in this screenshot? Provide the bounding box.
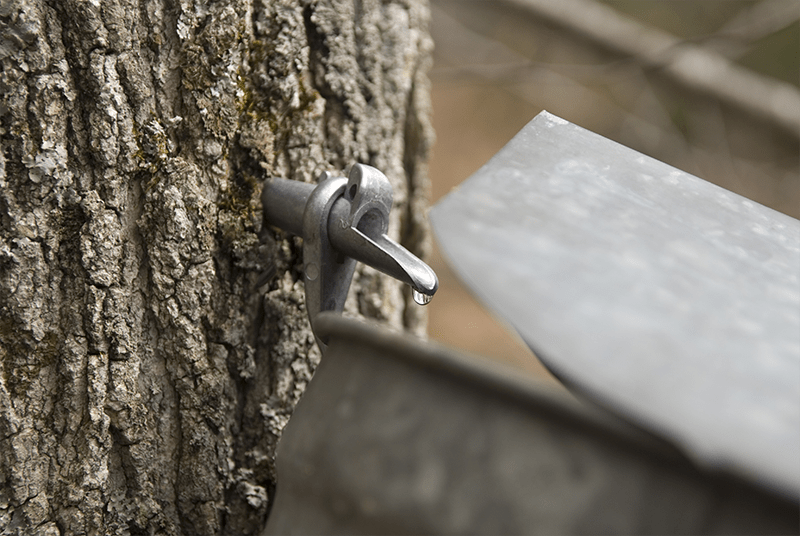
[431,112,800,500]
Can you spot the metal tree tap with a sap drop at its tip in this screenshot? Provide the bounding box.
[261,164,439,350]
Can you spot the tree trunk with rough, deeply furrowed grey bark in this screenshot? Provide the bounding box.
[0,0,432,534]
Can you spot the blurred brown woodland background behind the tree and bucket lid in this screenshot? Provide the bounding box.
[428,0,800,384]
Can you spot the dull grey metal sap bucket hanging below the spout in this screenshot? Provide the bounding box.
[265,313,800,535]
